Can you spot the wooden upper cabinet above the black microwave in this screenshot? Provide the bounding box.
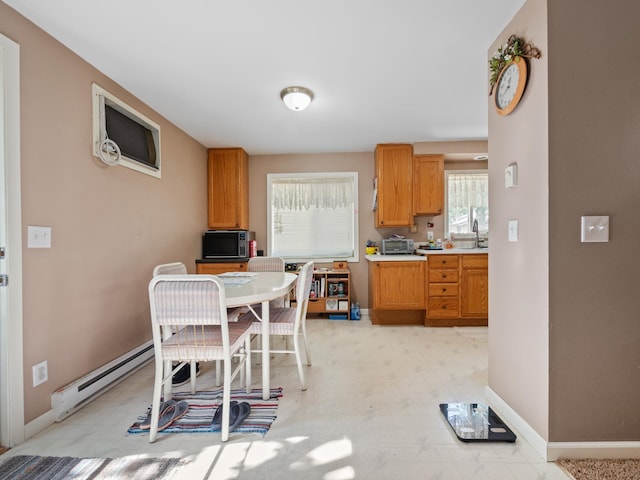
[207,148,249,230]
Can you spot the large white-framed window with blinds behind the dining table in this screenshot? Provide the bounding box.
[267,172,358,261]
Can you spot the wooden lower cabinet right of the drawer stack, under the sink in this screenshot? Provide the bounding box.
[460,255,489,318]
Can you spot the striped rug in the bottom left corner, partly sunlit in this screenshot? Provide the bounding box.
[0,455,182,480]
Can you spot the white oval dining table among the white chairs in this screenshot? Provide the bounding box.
[221,272,298,400]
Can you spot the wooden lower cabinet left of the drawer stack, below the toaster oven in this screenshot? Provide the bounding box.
[369,261,425,324]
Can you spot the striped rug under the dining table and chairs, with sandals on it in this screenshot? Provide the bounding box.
[127,387,282,436]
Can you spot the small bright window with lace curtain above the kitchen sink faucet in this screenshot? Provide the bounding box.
[445,170,489,237]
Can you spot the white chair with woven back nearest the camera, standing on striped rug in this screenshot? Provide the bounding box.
[149,275,251,442]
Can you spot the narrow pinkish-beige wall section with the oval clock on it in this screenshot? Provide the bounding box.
[487,0,549,439]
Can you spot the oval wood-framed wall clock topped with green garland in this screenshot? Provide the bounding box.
[489,35,541,115]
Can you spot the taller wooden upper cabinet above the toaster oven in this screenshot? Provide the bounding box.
[375,144,413,227]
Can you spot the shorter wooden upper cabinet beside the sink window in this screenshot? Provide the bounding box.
[413,155,444,215]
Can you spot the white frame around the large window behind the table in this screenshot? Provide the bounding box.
[267,172,360,263]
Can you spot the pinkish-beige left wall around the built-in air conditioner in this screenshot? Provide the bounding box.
[0,2,207,422]
